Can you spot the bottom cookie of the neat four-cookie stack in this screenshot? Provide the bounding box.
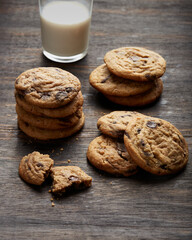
[18,114,85,140]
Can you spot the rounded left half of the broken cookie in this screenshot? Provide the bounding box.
[19,152,54,185]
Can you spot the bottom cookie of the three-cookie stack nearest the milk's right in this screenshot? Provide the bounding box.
[105,78,163,107]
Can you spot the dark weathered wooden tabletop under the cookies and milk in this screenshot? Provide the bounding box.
[0,0,192,240]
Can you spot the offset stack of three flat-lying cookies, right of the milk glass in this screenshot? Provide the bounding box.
[89,47,166,107]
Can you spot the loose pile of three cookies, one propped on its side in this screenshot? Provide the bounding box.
[87,111,188,176]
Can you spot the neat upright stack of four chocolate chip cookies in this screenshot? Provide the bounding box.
[15,67,85,140]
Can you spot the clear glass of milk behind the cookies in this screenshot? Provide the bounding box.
[39,0,93,63]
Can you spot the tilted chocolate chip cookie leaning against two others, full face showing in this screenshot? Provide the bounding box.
[124,117,188,175]
